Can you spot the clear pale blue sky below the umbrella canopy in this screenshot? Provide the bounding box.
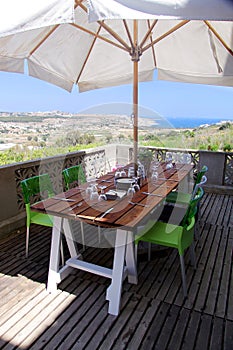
[0,72,233,120]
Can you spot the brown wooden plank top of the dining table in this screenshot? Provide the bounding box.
[31,163,193,230]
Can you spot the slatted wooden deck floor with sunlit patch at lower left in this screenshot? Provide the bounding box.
[0,194,233,350]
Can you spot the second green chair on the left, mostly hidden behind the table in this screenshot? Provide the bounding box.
[62,164,87,250]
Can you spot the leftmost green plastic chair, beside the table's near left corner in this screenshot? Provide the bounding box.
[21,174,63,259]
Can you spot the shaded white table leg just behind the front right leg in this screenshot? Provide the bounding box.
[125,231,138,284]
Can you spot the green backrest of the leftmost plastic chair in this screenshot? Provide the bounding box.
[21,174,54,204]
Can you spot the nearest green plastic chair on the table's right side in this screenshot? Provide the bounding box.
[135,187,204,297]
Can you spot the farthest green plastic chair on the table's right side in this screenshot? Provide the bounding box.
[165,165,208,205]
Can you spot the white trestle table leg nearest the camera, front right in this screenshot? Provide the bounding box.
[106,229,128,315]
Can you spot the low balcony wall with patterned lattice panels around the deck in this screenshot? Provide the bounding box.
[0,145,233,236]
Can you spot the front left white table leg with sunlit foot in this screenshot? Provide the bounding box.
[47,216,63,293]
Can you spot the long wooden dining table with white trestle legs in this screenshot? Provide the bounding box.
[31,163,193,315]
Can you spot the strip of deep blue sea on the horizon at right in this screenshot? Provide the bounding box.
[147,117,233,129]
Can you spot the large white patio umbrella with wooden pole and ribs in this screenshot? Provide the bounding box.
[0,0,233,163]
